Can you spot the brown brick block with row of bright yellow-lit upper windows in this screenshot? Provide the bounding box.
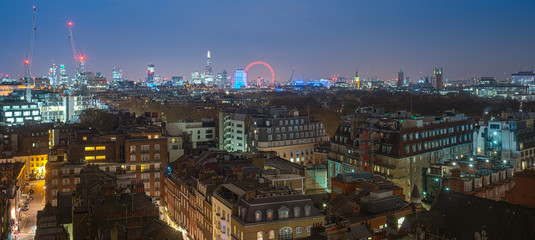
[45,126,168,206]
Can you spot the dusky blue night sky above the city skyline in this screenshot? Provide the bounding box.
[0,0,535,81]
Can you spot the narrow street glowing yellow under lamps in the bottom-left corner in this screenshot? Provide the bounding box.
[17,180,45,240]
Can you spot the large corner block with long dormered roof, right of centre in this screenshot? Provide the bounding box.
[327,108,474,199]
